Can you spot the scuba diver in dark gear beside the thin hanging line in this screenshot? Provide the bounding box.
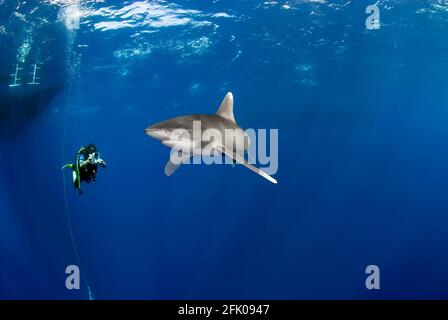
[61,143,106,194]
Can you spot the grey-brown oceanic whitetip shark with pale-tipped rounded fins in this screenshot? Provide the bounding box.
[145,92,277,183]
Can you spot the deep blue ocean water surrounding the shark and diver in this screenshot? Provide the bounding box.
[0,0,448,299]
